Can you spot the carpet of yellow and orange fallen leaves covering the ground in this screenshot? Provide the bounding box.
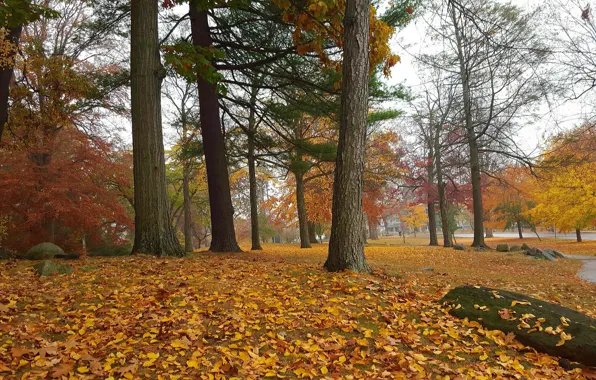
[0,245,596,379]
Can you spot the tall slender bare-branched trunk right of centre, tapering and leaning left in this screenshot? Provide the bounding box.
[451,6,485,247]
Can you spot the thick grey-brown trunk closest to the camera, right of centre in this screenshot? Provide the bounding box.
[325,0,370,272]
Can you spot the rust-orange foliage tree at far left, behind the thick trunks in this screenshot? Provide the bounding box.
[0,14,132,252]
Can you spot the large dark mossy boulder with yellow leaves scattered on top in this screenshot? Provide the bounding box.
[440,286,596,366]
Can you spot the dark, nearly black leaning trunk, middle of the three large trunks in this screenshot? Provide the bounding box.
[189,0,241,252]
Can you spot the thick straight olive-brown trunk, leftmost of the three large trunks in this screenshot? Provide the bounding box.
[130,0,184,256]
